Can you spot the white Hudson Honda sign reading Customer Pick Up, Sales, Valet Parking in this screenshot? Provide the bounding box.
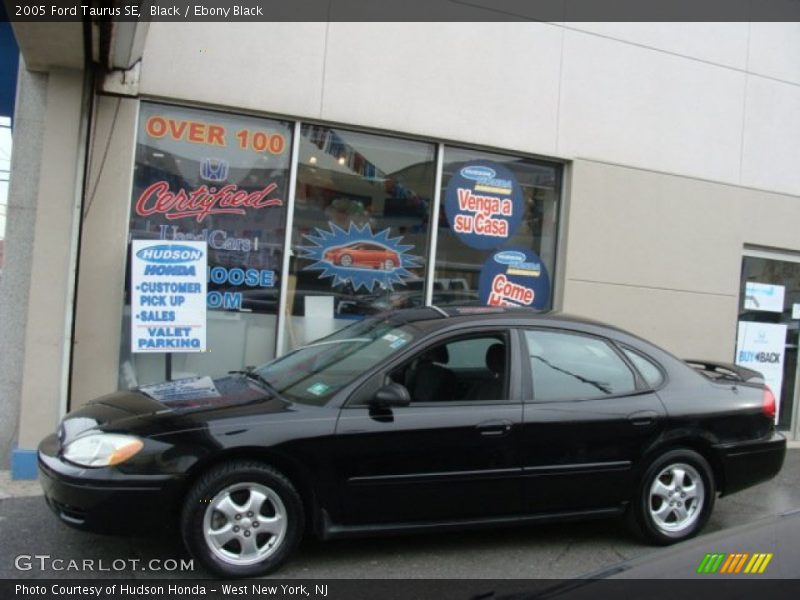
[131,240,208,352]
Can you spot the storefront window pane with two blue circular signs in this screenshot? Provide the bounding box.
[433,147,561,310]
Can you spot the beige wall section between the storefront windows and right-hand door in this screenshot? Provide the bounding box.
[562,160,800,361]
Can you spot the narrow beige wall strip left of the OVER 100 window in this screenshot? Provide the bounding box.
[72,96,139,408]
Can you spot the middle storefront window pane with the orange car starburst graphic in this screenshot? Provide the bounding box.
[284,125,436,349]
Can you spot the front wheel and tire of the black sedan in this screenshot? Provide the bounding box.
[181,461,305,577]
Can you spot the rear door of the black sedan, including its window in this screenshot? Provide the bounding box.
[521,329,666,512]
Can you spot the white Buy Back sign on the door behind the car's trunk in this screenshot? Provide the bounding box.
[736,321,786,422]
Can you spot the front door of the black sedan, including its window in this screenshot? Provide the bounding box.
[332,329,523,524]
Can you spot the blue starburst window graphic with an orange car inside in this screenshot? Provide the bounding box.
[298,223,422,292]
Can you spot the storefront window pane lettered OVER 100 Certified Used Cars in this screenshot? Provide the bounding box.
[120,102,292,388]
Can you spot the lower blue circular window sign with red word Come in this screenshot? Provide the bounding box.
[478,248,550,310]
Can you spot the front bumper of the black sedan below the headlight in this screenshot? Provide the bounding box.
[39,435,184,535]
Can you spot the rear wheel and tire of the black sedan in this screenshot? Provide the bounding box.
[628,449,716,546]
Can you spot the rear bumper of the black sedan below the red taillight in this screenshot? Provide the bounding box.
[716,432,786,496]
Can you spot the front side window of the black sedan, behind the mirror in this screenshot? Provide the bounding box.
[389,334,508,404]
